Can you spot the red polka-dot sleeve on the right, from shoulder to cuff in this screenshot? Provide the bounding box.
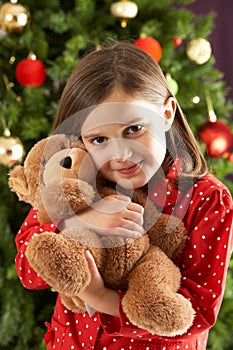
[100,180,233,339]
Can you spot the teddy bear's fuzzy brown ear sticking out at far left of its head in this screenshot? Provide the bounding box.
[8,165,29,202]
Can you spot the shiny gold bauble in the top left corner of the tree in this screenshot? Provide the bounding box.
[0,2,30,32]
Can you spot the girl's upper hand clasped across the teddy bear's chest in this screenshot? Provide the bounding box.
[59,195,144,238]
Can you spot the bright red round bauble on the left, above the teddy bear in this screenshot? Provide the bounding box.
[15,58,46,88]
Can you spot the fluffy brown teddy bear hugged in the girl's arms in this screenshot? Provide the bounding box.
[9,134,195,336]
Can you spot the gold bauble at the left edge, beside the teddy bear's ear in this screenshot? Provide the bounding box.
[0,129,25,167]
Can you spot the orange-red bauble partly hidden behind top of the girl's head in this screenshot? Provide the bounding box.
[134,36,162,62]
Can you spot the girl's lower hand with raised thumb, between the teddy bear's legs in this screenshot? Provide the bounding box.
[78,250,120,316]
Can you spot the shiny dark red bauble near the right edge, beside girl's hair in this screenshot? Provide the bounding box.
[198,120,232,157]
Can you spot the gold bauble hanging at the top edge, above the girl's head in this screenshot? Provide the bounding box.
[110,0,138,28]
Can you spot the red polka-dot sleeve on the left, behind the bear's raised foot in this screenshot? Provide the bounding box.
[15,208,56,289]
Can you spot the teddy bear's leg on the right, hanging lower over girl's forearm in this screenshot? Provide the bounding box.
[122,247,194,336]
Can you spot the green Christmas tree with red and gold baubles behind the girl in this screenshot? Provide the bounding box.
[0,0,233,350]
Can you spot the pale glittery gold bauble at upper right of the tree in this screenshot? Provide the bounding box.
[186,38,212,65]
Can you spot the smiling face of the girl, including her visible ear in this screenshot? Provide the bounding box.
[81,91,175,189]
